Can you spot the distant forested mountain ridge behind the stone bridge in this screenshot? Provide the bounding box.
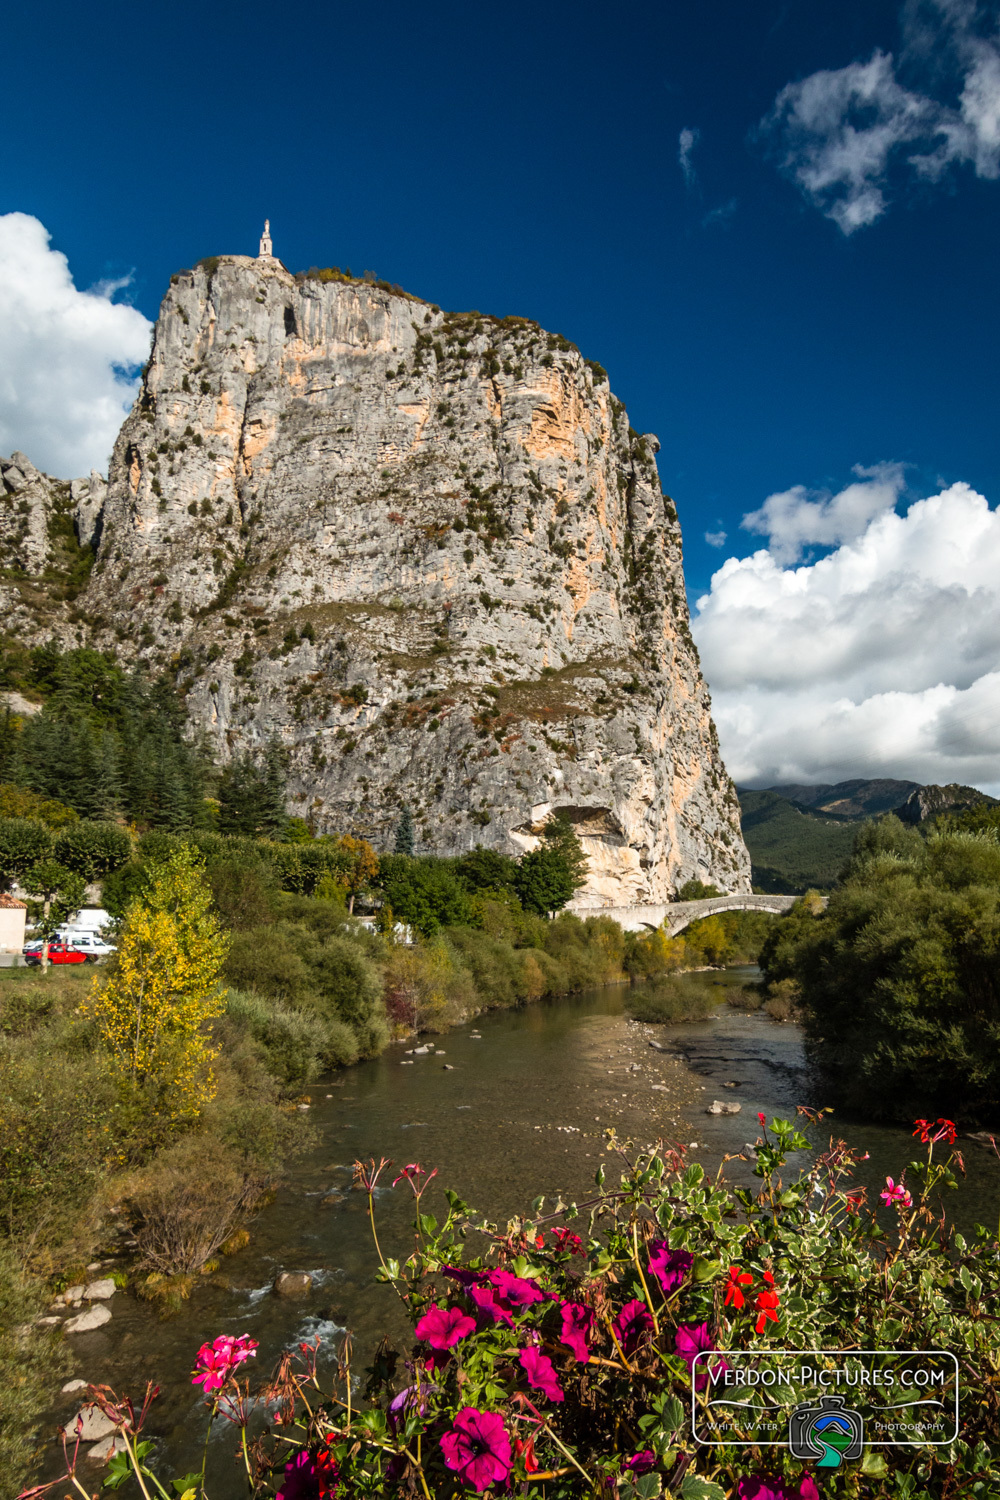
[738,777,1000,894]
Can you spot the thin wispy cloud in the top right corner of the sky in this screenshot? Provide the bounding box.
[762,0,1000,234]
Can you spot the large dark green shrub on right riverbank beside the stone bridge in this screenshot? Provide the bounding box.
[762,818,1000,1125]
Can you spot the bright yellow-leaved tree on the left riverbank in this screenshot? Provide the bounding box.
[82,848,229,1128]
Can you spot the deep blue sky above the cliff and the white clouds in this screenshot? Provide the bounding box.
[0,0,1000,780]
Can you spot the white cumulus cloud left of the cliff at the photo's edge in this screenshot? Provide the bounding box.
[0,213,153,479]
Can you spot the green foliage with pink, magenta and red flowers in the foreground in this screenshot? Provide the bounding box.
[30,1110,1000,1500]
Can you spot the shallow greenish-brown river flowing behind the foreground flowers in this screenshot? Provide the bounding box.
[46,969,1000,1500]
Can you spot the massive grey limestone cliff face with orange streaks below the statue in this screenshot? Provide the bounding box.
[3,257,750,906]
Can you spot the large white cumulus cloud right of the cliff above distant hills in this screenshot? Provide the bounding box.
[693,482,1000,792]
